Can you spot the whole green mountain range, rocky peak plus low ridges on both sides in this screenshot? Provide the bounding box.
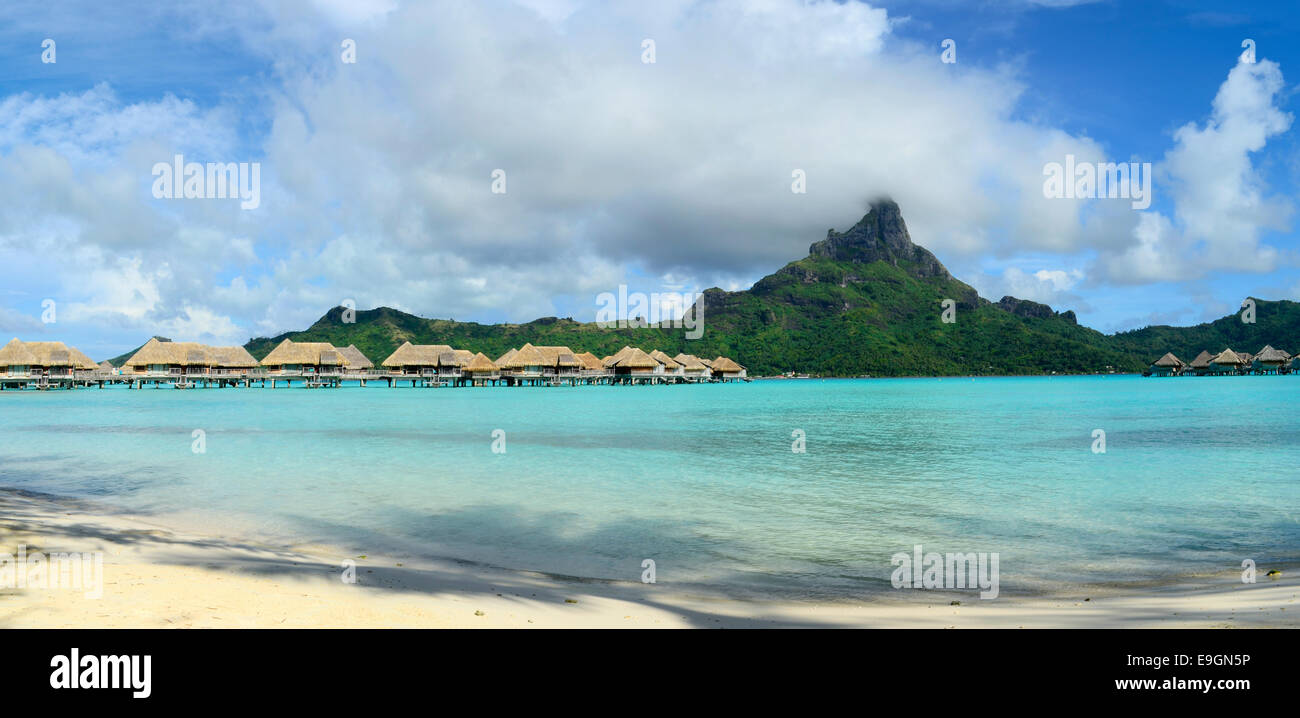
[233,199,1300,376]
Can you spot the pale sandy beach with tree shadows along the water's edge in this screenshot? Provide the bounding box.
[0,490,1300,628]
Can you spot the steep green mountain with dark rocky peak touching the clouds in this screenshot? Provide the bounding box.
[681,200,1145,376]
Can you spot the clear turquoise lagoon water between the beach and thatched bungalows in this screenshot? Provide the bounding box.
[0,376,1300,597]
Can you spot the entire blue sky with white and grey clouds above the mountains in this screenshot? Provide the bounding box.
[0,0,1300,359]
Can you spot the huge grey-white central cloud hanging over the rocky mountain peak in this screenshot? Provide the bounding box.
[245,0,1100,308]
